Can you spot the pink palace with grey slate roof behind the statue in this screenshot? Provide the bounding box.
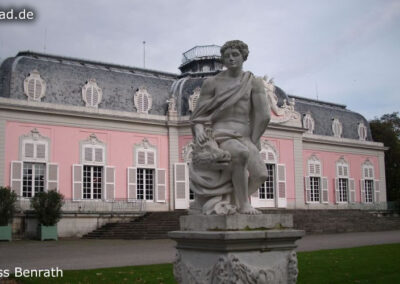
[0,45,386,236]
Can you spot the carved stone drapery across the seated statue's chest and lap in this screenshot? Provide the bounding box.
[189,72,262,215]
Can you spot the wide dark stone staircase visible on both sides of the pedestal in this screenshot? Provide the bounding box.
[83,209,400,239]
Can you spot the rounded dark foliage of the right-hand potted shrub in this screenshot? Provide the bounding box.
[31,190,64,226]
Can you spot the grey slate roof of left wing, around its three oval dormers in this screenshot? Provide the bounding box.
[0,52,177,115]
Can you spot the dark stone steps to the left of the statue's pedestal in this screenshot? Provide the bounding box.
[82,210,187,239]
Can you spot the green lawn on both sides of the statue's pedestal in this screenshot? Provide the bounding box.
[8,243,400,284]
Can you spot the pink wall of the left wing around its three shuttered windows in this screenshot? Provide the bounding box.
[4,121,169,200]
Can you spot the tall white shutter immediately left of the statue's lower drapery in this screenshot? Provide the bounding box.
[174,163,189,209]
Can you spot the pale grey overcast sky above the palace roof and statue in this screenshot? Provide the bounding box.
[0,0,400,119]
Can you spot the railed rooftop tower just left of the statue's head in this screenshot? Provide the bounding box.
[179,45,223,76]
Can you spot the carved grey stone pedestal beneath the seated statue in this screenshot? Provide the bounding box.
[169,214,304,284]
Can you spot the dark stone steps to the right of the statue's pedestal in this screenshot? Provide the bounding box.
[263,209,400,234]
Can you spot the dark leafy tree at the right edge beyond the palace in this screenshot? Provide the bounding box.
[369,112,400,202]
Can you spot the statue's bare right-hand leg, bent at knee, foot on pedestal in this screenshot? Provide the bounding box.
[220,139,259,214]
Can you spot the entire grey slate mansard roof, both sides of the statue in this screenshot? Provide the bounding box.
[0,52,372,141]
